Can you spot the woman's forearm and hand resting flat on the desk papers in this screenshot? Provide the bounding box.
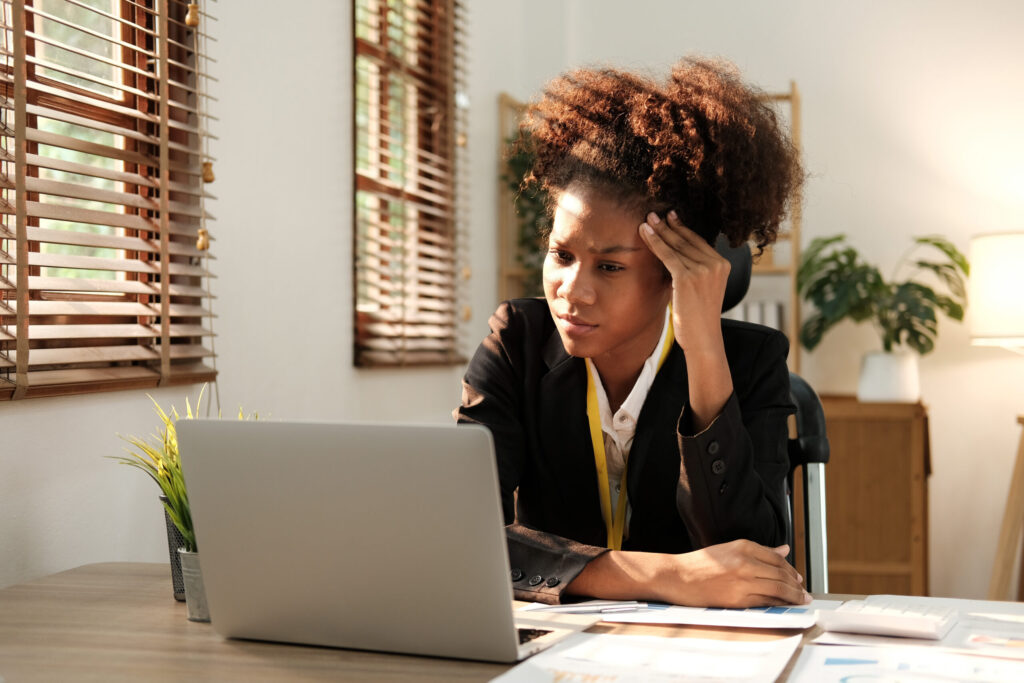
[567,540,811,607]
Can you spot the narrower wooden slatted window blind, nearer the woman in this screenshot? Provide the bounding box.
[353,0,469,367]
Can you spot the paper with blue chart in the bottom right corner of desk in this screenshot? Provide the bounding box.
[788,638,1024,683]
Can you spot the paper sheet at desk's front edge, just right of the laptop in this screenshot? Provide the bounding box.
[494,633,801,683]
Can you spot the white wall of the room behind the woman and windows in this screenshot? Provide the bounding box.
[6,0,1024,596]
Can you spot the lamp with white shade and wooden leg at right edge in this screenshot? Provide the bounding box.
[968,232,1024,600]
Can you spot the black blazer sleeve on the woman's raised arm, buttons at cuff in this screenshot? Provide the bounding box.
[676,332,795,547]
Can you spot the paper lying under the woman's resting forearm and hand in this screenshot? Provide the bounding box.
[522,600,842,629]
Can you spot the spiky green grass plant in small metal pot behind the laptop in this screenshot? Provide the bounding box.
[111,386,258,622]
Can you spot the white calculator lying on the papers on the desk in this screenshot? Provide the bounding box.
[818,597,957,640]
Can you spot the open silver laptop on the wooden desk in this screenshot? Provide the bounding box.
[177,420,596,661]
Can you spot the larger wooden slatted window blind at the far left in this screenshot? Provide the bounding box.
[0,0,216,399]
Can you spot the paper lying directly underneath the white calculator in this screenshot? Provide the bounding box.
[814,595,1024,659]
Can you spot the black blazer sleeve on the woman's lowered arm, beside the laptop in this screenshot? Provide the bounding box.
[454,302,607,604]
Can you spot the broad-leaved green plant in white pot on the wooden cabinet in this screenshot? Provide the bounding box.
[797,234,970,402]
